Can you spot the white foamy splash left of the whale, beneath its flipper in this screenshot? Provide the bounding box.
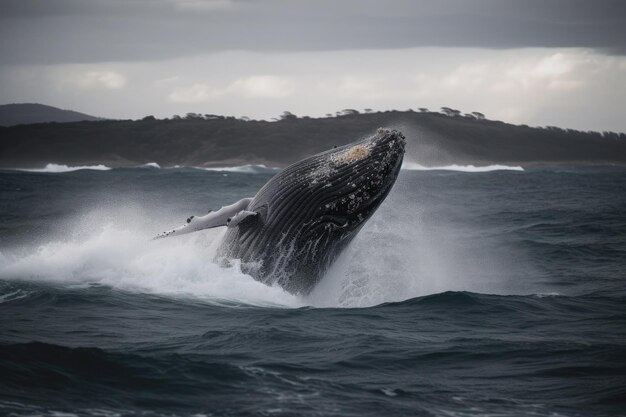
[0,213,302,307]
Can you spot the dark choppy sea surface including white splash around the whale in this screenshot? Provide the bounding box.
[0,164,626,417]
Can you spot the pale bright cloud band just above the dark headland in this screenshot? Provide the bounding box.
[0,48,626,131]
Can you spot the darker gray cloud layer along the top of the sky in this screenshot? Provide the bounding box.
[0,0,626,65]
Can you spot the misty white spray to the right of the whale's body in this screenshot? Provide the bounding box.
[306,177,530,308]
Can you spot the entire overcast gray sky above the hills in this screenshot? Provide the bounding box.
[0,0,626,131]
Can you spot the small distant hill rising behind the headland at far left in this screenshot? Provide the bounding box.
[0,103,102,126]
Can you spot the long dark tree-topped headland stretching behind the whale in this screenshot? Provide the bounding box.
[0,111,626,168]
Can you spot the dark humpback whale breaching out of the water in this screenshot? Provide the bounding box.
[155,129,406,295]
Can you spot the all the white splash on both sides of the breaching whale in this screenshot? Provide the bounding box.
[0,176,537,308]
